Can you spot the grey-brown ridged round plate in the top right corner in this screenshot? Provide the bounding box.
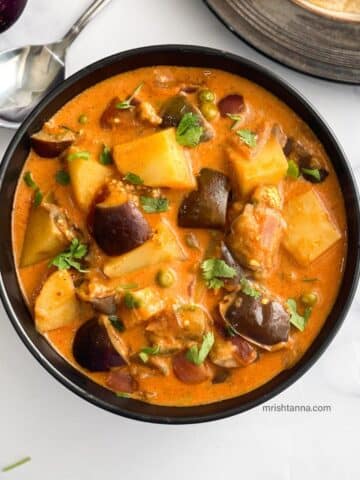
[205,0,360,84]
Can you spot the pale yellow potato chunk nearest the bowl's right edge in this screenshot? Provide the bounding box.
[283,190,341,266]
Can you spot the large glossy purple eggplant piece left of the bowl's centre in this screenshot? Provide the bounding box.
[93,201,151,256]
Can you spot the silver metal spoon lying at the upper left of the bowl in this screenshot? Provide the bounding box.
[0,0,111,128]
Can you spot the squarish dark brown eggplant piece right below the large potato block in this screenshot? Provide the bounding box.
[178,168,230,229]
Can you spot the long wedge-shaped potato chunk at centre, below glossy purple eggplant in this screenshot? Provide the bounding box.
[103,222,186,278]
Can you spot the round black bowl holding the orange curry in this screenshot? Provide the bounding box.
[0,45,360,424]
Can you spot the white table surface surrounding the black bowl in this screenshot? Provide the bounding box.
[0,0,360,480]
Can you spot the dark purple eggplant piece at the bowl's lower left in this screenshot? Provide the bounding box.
[72,318,126,372]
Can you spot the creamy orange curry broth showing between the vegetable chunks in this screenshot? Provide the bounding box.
[13,67,346,406]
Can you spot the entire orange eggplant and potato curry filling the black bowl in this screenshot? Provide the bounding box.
[13,66,346,407]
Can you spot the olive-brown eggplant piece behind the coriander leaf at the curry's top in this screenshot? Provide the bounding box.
[160,94,214,142]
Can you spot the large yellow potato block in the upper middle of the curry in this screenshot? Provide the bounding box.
[114,128,196,189]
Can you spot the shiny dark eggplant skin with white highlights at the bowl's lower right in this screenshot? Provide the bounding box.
[225,292,290,345]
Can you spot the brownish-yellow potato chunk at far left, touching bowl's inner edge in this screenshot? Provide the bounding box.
[20,205,69,267]
